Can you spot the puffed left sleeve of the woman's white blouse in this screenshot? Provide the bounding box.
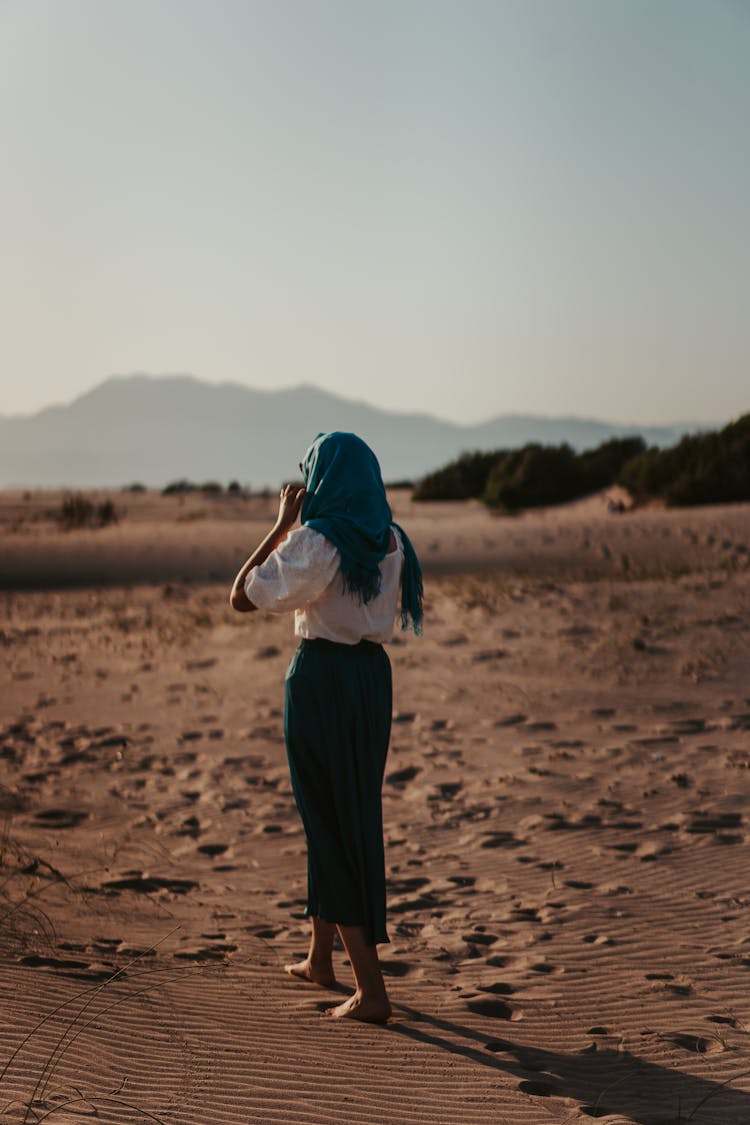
[245,527,340,613]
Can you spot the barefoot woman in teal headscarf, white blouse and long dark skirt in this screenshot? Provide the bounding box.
[229,433,422,1023]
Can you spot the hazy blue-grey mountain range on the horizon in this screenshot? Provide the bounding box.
[0,375,698,488]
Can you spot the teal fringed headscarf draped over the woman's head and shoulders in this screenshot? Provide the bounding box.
[300,432,422,633]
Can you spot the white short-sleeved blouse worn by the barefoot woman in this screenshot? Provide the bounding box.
[245,524,404,645]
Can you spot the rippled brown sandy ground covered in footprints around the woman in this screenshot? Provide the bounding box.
[0,494,750,1125]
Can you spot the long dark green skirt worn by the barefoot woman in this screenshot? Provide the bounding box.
[284,639,391,945]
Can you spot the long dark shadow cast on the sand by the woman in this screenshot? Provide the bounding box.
[387,1004,750,1125]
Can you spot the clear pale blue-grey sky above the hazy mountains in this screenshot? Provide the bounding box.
[0,0,750,423]
